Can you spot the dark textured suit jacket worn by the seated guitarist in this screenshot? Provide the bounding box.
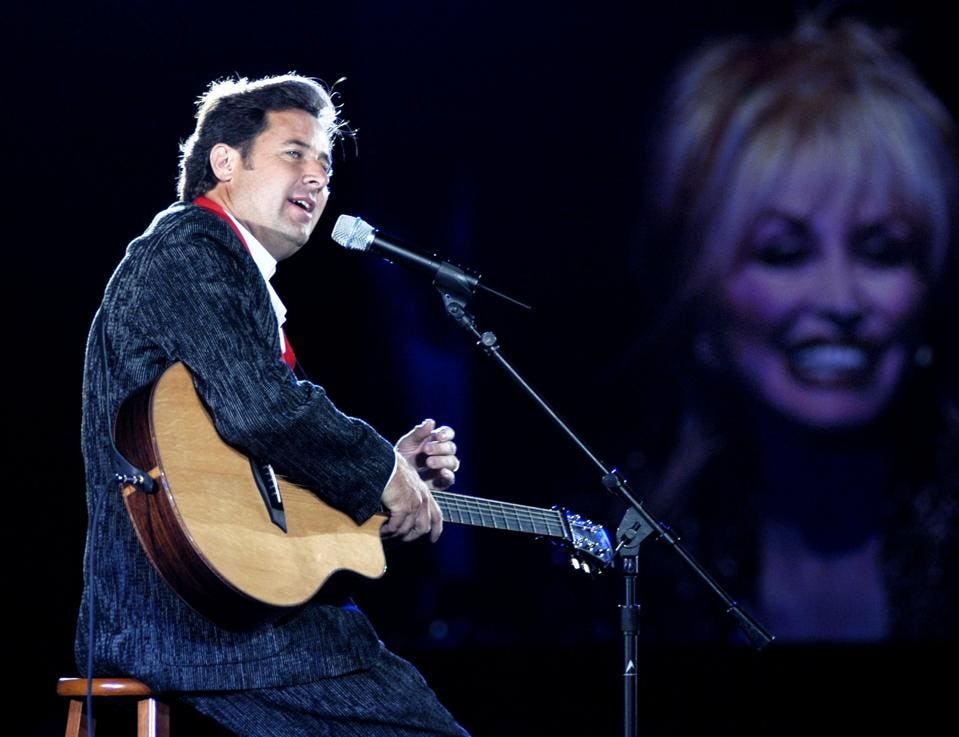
[76,203,393,690]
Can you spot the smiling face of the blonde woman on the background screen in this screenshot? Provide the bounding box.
[711,165,928,428]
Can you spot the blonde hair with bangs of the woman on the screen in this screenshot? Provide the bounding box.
[655,20,956,303]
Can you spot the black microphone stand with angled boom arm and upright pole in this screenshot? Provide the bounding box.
[433,262,773,737]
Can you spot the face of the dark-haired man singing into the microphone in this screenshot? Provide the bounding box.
[218,110,330,260]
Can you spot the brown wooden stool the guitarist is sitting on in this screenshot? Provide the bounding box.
[57,678,170,737]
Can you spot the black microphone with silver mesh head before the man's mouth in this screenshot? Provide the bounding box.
[332,215,531,310]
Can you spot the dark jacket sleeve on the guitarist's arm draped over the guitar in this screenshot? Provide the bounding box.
[137,216,394,522]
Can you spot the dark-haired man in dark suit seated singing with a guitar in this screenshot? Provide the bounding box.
[76,75,465,737]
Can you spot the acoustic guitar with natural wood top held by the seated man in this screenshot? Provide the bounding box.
[115,363,613,628]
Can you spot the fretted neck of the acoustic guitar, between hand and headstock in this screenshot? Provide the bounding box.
[433,491,568,539]
